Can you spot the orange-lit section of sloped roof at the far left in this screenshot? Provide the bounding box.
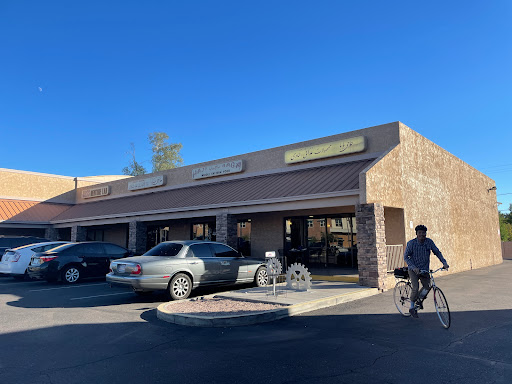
[0,199,72,223]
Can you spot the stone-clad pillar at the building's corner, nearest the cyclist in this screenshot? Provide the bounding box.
[356,203,387,291]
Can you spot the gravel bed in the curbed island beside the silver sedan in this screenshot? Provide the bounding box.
[165,297,286,317]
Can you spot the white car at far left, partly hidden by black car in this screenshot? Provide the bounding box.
[0,241,69,279]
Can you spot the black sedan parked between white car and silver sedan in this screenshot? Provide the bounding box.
[28,241,132,283]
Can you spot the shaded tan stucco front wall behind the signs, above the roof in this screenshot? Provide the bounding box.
[77,122,399,203]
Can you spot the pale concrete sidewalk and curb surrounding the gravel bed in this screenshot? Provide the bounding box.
[157,281,379,327]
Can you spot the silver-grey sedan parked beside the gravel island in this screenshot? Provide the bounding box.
[107,240,268,300]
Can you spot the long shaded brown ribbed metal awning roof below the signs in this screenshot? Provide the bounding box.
[52,159,375,222]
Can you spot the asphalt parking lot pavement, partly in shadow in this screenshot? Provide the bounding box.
[0,260,512,384]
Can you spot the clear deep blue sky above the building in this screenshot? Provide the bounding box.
[0,0,512,210]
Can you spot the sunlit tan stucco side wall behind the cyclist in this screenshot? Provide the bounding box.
[365,123,502,272]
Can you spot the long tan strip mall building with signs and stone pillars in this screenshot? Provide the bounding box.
[0,122,502,289]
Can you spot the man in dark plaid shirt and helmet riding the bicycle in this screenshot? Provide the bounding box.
[404,225,449,318]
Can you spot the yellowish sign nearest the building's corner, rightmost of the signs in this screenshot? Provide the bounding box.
[284,136,366,164]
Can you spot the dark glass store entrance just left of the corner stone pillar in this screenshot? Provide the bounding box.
[284,214,357,272]
